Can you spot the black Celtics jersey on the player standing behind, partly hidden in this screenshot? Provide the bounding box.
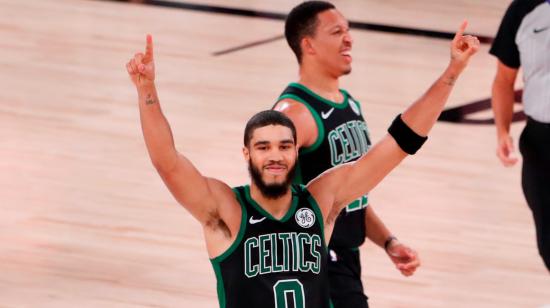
[277,83,371,249]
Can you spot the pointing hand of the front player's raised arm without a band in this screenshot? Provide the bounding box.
[126,34,155,88]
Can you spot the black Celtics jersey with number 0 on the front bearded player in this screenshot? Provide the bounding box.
[211,184,330,308]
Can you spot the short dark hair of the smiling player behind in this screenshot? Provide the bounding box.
[285,1,335,63]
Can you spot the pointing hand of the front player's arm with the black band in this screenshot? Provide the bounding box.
[451,21,479,72]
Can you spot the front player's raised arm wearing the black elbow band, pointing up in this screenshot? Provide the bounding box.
[308,22,479,219]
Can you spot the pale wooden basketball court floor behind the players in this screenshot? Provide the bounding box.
[0,0,550,307]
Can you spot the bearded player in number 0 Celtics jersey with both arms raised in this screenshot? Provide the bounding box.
[126,23,479,308]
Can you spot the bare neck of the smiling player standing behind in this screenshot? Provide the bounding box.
[298,64,344,103]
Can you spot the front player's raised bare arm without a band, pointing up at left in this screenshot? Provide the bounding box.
[126,35,234,225]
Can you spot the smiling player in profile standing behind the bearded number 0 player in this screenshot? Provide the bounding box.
[274,1,420,308]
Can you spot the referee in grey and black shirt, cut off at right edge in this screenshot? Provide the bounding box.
[490,0,550,270]
